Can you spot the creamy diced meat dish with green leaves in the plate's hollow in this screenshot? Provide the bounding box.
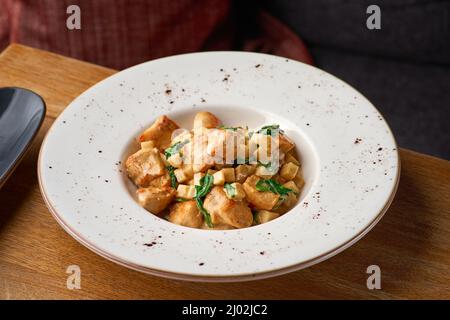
[125,112,304,230]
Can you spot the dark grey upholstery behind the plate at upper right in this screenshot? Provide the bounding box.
[263,0,450,159]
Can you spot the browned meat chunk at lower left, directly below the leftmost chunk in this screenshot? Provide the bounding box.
[136,187,175,215]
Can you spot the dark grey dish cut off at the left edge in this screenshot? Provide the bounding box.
[0,88,45,187]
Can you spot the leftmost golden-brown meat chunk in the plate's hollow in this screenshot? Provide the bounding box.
[125,148,165,187]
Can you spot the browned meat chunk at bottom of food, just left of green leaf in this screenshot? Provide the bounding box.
[169,200,203,228]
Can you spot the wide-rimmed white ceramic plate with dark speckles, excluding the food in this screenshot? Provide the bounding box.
[38,52,399,281]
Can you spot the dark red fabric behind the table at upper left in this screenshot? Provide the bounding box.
[0,0,312,69]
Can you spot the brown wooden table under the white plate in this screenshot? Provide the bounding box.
[0,45,450,299]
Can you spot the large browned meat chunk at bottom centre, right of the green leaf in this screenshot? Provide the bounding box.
[203,186,253,228]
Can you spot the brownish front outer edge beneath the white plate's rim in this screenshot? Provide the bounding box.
[38,164,401,282]
